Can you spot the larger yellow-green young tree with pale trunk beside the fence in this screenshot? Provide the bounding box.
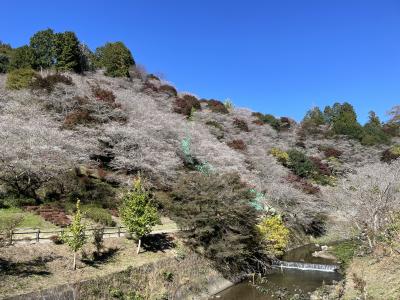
[120,177,160,254]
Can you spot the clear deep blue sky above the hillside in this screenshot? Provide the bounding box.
[0,0,400,122]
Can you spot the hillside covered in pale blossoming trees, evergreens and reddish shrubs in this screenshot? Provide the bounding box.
[0,29,400,298]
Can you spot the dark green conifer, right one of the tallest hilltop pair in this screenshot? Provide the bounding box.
[54,31,82,73]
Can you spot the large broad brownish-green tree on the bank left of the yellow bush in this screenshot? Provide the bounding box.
[170,172,263,274]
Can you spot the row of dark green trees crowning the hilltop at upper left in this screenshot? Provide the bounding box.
[0,29,135,77]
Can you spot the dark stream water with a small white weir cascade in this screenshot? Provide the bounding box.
[212,245,342,300]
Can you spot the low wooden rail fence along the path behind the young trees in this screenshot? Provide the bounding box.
[0,226,178,245]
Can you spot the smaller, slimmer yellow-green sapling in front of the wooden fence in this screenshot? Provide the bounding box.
[61,200,86,270]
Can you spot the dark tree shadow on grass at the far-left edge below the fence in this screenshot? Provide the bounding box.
[0,256,57,277]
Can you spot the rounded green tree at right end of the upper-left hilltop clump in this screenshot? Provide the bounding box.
[96,42,135,77]
